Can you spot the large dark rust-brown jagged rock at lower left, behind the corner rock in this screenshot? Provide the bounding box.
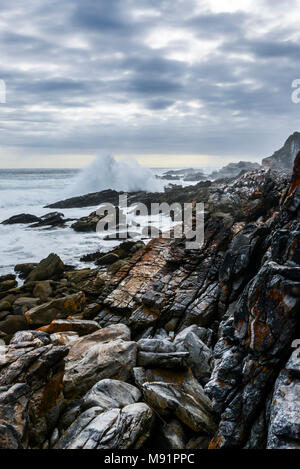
[0,331,68,448]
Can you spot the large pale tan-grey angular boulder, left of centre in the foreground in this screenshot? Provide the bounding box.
[64,324,137,399]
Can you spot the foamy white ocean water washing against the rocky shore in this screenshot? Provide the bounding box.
[0,163,211,275]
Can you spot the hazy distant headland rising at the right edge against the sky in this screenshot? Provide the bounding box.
[262,132,300,170]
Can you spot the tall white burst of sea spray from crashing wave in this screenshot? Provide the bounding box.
[68,155,164,195]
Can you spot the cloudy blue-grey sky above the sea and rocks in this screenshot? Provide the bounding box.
[0,0,300,168]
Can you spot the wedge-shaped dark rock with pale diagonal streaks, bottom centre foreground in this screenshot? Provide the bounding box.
[134,368,216,435]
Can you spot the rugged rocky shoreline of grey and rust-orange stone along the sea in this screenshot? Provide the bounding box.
[0,154,300,449]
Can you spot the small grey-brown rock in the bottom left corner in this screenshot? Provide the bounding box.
[0,384,30,449]
